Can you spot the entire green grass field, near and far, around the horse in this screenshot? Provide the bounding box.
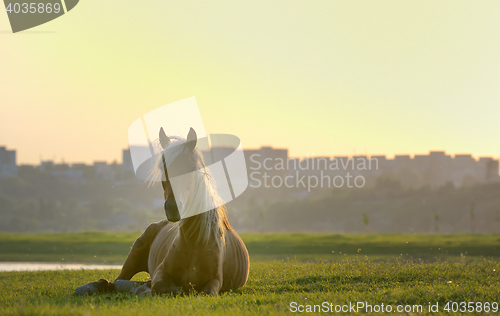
[0,233,500,316]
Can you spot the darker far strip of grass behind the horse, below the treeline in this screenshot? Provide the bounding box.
[0,232,500,264]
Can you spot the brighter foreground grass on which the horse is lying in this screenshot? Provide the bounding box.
[0,259,500,316]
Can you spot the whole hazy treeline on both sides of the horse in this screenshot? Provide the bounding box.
[0,166,500,233]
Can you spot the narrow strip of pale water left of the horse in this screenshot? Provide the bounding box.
[0,262,122,272]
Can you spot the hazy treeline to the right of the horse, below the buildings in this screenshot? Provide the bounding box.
[232,177,500,233]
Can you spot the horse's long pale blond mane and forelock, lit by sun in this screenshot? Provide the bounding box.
[149,136,230,248]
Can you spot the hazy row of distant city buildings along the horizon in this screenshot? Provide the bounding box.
[0,146,500,192]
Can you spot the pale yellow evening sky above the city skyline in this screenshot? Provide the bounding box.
[0,0,500,164]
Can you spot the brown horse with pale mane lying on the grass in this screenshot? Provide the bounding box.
[77,128,250,296]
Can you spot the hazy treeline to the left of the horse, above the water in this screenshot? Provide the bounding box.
[0,166,162,232]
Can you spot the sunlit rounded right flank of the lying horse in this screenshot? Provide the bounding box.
[221,229,250,292]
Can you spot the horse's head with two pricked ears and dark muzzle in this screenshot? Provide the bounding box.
[160,128,198,222]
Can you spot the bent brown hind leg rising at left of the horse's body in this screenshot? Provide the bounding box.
[115,219,169,281]
